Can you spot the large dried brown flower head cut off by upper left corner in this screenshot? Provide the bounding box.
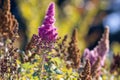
[0,0,18,39]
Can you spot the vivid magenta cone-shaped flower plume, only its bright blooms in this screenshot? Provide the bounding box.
[38,3,58,42]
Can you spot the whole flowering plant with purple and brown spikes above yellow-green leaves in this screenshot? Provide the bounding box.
[0,0,120,80]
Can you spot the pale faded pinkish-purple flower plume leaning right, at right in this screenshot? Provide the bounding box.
[83,27,109,66]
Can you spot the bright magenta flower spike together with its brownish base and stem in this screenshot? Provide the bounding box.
[26,3,58,78]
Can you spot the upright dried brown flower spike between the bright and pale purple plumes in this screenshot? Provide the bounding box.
[68,29,80,68]
